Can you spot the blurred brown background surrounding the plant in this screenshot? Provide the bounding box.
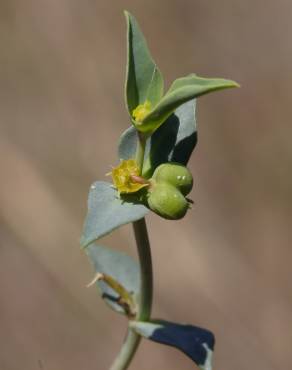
[0,0,292,370]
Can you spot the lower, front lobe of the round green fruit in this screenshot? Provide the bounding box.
[148,182,189,220]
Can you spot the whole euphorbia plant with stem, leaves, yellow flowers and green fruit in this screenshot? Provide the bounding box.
[81,12,238,370]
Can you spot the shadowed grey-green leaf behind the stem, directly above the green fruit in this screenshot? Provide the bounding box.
[118,100,197,177]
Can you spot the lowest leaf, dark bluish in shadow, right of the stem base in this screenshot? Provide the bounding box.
[130,320,215,370]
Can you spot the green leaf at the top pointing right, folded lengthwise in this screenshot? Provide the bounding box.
[139,74,238,134]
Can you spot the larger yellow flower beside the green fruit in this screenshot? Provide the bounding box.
[111,159,148,193]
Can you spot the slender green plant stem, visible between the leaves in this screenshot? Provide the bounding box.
[110,133,153,370]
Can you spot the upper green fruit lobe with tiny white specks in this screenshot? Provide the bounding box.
[152,162,193,195]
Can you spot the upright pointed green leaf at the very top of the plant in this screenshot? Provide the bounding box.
[125,12,163,117]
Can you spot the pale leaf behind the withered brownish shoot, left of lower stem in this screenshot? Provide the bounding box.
[86,244,140,314]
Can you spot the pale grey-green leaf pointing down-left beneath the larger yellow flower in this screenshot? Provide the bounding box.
[80,181,149,247]
